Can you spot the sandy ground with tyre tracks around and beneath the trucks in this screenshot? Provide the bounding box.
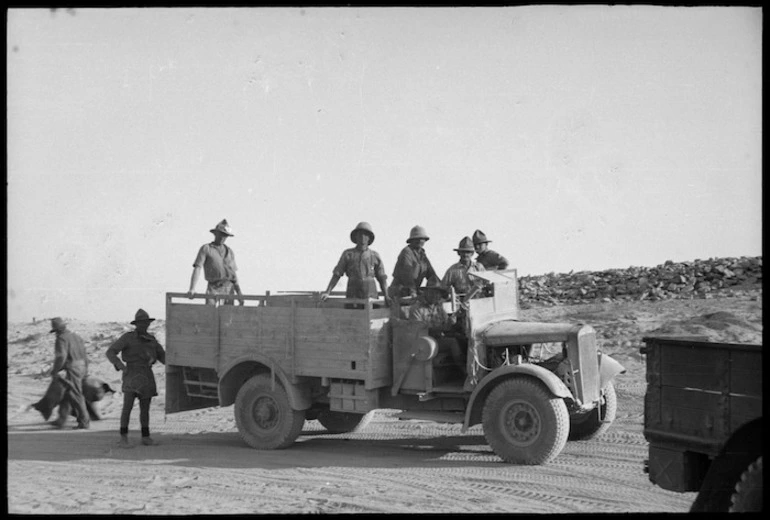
[7,291,762,515]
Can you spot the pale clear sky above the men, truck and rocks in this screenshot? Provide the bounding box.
[6,5,763,322]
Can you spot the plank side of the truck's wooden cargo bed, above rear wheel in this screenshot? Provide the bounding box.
[166,294,392,389]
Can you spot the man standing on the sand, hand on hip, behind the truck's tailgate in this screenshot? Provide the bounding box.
[106,309,166,448]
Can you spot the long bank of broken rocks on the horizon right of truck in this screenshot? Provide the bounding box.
[519,256,762,305]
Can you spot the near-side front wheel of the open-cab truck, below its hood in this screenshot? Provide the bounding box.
[481,377,569,465]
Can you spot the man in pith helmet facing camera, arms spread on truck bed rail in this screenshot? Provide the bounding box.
[321,222,390,305]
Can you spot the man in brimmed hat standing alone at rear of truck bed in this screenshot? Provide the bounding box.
[187,219,243,305]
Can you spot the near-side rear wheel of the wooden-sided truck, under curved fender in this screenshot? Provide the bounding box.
[234,374,305,450]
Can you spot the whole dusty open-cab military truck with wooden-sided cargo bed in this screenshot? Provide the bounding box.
[165,269,625,464]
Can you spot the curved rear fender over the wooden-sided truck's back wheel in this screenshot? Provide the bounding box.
[219,353,313,410]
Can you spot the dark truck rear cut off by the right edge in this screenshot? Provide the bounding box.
[641,337,763,512]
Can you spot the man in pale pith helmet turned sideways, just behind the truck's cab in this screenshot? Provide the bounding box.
[388,226,438,318]
